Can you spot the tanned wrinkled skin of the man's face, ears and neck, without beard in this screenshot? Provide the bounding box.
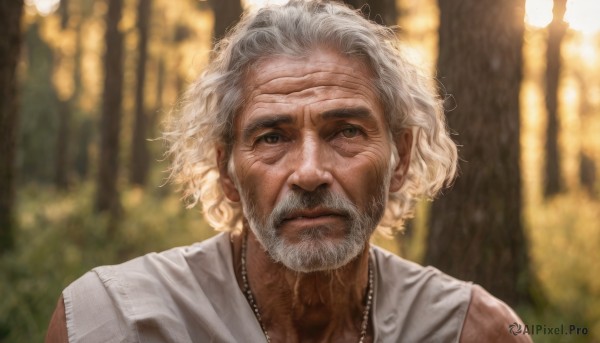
[218,49,412,342]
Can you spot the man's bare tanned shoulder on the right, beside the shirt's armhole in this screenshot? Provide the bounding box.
[460,285,532,343]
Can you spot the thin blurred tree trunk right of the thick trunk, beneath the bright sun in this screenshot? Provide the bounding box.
[544,0,567,198]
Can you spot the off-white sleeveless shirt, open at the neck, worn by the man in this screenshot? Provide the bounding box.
[63,233,472,343]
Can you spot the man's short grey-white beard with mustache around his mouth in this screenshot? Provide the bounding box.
[238,179,391,273]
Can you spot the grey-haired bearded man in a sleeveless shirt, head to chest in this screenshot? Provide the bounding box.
[48,1,528,342]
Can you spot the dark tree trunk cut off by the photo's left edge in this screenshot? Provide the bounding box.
[0,0,23,254]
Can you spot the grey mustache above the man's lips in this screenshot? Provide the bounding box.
[269,188,358,227]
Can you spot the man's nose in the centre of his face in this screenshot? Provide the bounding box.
[288,137,333,192]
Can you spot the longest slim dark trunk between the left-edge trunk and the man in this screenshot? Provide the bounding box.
[96,0,123,214]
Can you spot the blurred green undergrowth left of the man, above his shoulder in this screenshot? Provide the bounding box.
[0,184,214,342]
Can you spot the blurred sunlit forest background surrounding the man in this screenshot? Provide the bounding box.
[0,0,600,342]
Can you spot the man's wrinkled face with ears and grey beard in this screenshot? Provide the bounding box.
[218,49,410,272]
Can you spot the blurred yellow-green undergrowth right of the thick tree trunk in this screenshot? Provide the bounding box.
[522,191,600,342]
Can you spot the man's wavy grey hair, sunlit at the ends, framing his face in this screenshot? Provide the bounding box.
[163,0,457,234]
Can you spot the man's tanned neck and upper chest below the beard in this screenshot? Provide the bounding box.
[232,228,369,342]
